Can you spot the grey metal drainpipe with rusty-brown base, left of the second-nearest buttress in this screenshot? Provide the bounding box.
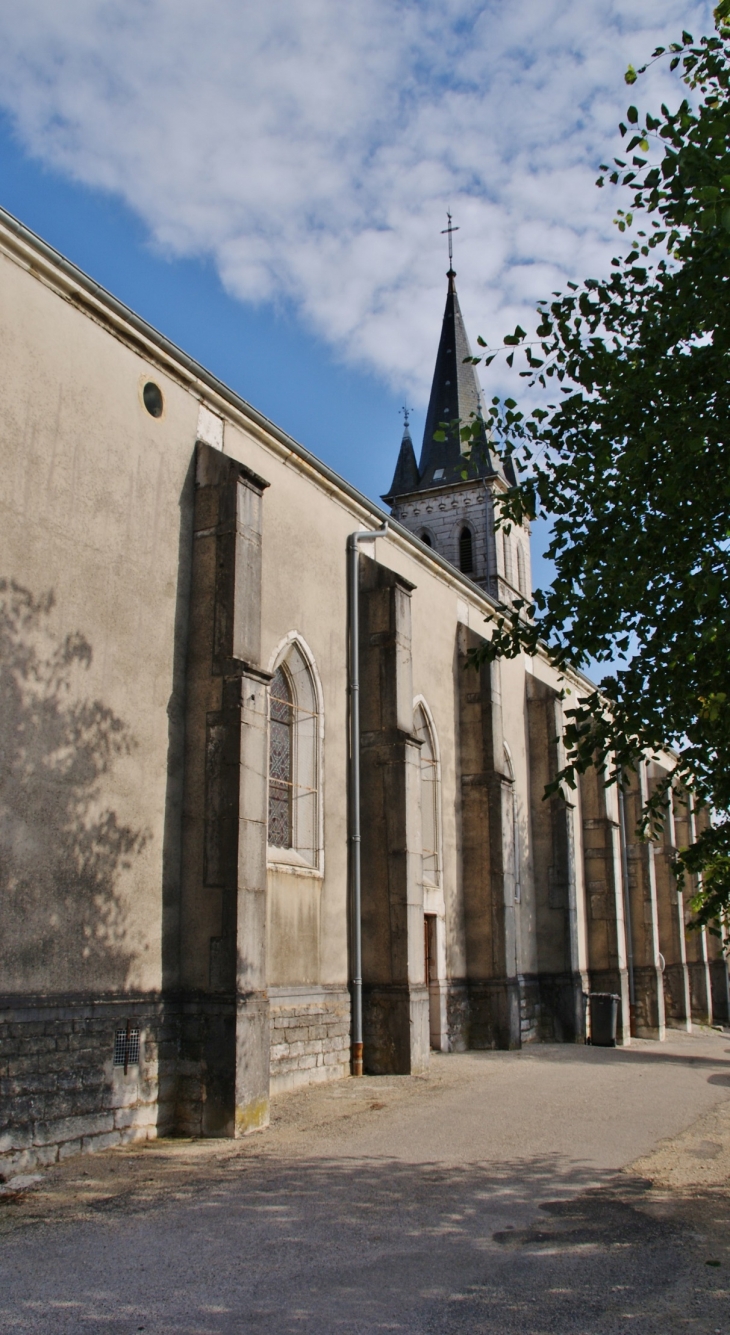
[347,519,388,1076]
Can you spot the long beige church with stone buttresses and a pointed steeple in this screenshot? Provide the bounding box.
[0,202,729,1171]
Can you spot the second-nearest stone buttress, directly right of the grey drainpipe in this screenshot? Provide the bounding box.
[359,554,430,1075]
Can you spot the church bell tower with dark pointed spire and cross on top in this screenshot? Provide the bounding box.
[382,237,532,602]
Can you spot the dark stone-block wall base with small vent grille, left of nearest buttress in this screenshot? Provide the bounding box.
[0,997,176,1173]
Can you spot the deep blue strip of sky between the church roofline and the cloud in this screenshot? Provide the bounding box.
[0,115,408,499]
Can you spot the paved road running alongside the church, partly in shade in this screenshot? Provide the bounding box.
[0,1033,730,1335]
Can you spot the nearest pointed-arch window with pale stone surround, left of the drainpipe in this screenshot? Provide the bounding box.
[268,639,322,868]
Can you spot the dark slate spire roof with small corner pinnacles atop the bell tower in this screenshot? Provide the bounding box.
[382,268,503,503]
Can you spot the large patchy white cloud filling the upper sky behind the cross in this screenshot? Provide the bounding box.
[0,0,711,402]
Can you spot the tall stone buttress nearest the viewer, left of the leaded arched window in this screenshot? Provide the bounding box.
[177,442,270,1136]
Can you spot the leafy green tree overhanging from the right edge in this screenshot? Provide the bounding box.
[463,0,730,925]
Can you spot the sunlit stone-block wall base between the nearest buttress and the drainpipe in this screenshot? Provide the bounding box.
[268,988,350,1093]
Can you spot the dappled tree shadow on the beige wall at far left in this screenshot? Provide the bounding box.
[0,579,148,992]
